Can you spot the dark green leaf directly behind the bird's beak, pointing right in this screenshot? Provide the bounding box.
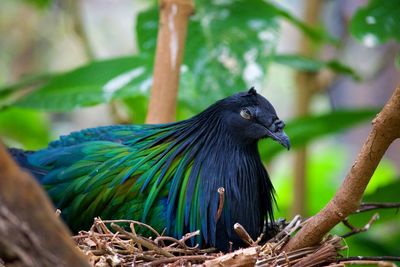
[259,110,378,160]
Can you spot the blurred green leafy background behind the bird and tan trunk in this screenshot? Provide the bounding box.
[0,0,400,256]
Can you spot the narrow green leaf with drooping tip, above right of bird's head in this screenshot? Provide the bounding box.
[272,54,360,80]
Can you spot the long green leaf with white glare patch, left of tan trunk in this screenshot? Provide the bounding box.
[12,56,151,111]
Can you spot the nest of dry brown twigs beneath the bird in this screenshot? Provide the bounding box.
[73,216,356,267]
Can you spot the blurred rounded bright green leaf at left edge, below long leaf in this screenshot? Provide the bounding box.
[0,108,50,149]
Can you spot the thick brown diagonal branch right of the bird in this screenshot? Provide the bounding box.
[285,87,400,251]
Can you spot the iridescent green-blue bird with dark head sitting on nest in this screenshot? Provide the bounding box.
[9,87,290,251]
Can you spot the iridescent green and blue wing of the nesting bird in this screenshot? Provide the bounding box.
[28,135,201,239]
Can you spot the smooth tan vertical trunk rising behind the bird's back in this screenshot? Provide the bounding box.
[146,0,194,123]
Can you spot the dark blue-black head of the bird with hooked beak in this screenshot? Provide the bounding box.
[218,88,290,149]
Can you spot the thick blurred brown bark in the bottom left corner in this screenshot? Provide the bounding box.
[0,144,90,267]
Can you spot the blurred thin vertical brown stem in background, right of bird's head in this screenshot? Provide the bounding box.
[292,0,322,215]
